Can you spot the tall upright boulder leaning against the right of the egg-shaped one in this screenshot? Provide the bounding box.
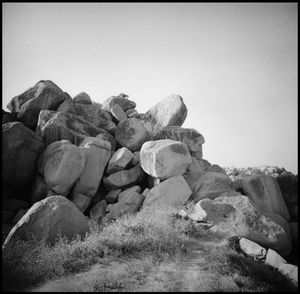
[73,138,111,198]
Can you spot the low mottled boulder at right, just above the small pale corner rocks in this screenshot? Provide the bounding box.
[193,192,292,257]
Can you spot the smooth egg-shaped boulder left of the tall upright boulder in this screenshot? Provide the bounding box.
[38,141,86,196]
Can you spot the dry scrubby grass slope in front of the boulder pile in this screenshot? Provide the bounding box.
[2,203,296,292]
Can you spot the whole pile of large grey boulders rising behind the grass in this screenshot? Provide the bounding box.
[2,81,298,276]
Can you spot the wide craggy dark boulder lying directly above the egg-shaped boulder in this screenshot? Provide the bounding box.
[35,110,115,146]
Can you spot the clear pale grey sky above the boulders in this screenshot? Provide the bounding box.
[2,3,298,173]
